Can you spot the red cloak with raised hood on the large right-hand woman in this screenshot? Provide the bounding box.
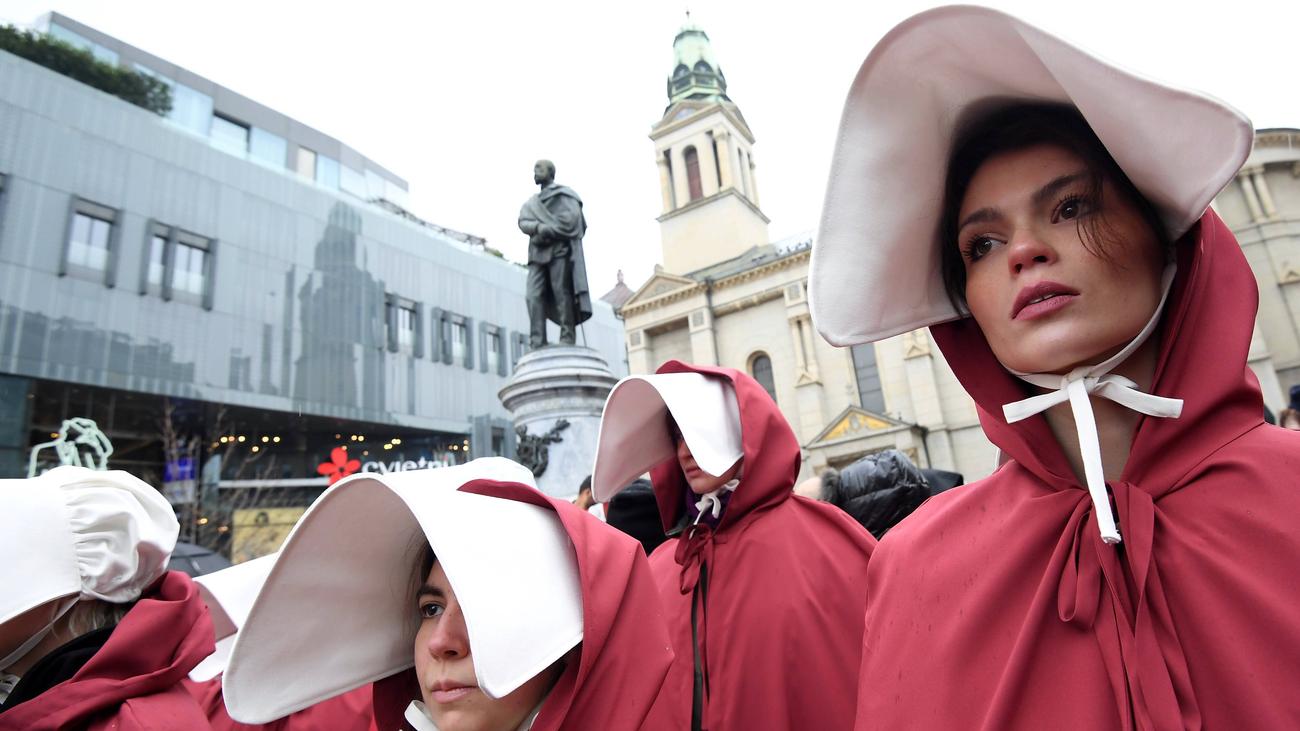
[857,211,1300,730]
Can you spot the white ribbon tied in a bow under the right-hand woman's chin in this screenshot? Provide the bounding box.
[1002,264,1183,544]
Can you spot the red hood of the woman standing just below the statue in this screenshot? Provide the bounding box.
[650,360,802,532]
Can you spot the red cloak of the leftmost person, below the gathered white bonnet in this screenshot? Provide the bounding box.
[0,571,216,731]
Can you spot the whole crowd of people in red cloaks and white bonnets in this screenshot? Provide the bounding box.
[0,7,1300,731]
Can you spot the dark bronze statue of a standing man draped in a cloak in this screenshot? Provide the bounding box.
[519,160,592,349]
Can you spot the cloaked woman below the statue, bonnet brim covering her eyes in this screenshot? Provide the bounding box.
[592,360,875,731]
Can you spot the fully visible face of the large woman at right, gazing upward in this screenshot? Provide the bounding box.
[949,144,1165,373]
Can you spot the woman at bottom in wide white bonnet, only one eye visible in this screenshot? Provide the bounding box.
[222,458,672,731]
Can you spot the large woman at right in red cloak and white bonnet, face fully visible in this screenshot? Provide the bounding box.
[811,7,1300,730]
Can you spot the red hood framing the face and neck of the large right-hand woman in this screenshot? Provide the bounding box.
[931,211,1264,498]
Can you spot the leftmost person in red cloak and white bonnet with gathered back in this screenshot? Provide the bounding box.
[0,467,213,731]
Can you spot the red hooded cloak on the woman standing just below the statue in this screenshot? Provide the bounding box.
[647,360,876,731]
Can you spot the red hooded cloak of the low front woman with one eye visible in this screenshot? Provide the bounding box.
[374,480,672,731]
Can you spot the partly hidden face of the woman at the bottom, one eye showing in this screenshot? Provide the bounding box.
[415,562,560,731]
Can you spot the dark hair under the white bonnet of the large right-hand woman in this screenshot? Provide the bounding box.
[939,104,1170,311]
